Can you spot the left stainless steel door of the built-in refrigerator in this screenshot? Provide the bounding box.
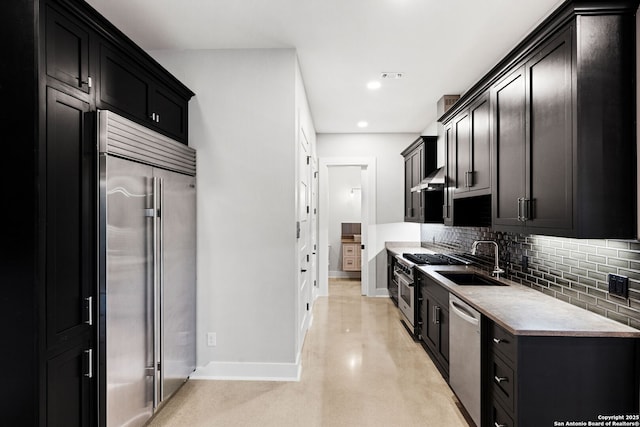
[100,156,154,426]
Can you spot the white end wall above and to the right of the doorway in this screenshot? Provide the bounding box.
[317,133,420,295]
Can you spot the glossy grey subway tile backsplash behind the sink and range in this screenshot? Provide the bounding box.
[421,224,640,329]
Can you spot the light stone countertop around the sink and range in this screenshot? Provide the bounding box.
[387,244,640,338]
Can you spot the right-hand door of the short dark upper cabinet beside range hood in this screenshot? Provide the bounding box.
[468,94,491,195]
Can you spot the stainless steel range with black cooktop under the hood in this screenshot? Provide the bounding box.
[393,253,469,339]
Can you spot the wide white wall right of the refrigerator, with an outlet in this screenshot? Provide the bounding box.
[150,49,298,377]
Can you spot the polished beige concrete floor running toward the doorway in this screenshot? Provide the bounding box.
[151,281,468,427]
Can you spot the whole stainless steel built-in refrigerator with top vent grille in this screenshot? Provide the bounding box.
[97,111,196,426]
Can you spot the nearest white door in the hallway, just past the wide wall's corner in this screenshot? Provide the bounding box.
[297,128,313,348]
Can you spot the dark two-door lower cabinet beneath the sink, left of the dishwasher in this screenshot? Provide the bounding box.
[416,272,449,379]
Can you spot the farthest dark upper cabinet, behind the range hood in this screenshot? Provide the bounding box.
[402,136,443,223]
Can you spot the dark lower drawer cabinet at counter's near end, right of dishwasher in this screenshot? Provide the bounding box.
[482,319,639,427]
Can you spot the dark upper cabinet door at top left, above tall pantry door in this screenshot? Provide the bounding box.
[45,7,90,93]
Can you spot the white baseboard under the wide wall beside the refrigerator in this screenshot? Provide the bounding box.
[189,361,302,381]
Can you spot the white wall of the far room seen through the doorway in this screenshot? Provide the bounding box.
[327,166,362,277]
